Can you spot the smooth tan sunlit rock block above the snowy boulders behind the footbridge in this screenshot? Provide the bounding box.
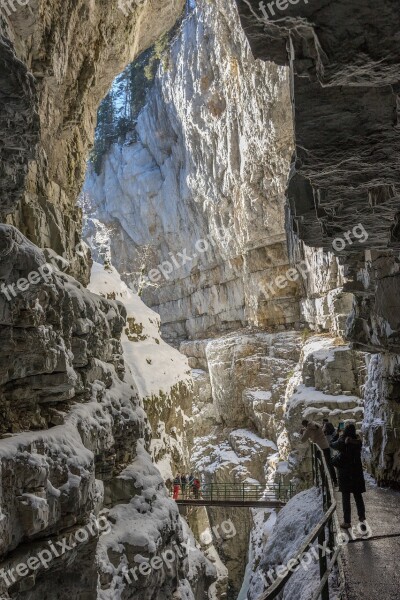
[181,332,301,428]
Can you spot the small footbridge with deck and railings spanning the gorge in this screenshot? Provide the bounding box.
[175,483,295,508]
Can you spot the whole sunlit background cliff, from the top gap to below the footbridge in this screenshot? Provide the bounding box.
[80,0,376,598]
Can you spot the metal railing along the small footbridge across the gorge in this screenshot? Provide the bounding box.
[170,482,295,502]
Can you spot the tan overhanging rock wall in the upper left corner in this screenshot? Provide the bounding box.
[0,0,184,281]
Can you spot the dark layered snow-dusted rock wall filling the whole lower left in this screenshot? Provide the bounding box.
[0,232,216,600]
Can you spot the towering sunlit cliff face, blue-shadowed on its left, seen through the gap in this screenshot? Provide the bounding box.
[85,0,299,340]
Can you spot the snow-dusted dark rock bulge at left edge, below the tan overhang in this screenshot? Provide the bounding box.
[0,273,149,555]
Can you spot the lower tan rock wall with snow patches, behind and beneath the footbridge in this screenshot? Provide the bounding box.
[180,330,369,598]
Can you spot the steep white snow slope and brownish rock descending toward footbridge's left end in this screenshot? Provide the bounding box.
[89,263,193,479]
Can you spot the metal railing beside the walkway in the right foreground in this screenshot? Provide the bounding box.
[259,444,345,600]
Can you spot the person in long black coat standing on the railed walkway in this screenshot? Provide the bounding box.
[331,424,366,529]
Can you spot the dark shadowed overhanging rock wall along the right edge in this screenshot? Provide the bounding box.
[237,0,400,485]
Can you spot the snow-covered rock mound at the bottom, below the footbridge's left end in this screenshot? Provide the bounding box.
[97,445,216,600]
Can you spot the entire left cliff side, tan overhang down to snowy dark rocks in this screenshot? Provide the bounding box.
[0,0,216,600]
